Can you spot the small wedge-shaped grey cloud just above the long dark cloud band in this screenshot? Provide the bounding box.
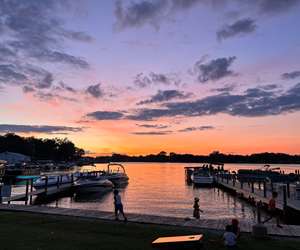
[137,90,192,105]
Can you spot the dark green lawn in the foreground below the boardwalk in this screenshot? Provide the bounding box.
[0,212,300,250]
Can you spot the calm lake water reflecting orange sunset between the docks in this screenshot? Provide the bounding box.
[38,163,300,221]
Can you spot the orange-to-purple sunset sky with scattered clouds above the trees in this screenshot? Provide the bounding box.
[0,0,300,155]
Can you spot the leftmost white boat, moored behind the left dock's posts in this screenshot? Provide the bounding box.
[33,175,72,189]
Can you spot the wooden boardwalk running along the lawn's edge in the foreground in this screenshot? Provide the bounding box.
[0,204,300,238]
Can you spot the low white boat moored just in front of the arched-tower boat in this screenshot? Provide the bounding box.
[75,176,114,193]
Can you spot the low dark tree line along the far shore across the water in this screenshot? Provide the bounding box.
[95,151,300,164]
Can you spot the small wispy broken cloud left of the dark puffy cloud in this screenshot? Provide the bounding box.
[134,72,180,88]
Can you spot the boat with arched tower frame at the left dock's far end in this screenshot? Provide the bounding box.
[103,163,129,185]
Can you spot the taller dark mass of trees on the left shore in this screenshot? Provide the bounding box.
[0,133,84,161]
